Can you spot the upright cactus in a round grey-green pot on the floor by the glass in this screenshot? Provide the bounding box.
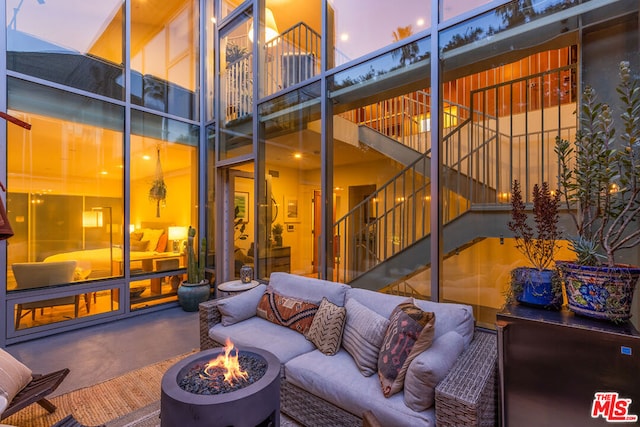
[178,226,211,311]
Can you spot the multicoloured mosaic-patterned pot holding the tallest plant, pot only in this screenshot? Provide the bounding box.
[556,262,640,322]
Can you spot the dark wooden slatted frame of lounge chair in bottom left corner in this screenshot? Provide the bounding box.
[0,368,69,420]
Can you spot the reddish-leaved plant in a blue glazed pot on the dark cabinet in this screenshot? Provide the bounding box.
[507,180,562,309]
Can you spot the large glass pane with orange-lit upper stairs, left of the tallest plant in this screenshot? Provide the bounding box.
[440,1,636,327]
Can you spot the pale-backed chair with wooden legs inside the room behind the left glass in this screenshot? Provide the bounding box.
[11,261,82,330]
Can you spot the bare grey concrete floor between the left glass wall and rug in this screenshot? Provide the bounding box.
[5,307,299,427]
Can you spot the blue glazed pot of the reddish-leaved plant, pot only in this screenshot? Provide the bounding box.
[511,267,562,310]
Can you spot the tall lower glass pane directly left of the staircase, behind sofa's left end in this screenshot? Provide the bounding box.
[255,83,323,278]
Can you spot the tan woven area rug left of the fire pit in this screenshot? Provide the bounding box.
[2,352,194,427]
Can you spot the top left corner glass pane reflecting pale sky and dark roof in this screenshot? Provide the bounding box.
[5,0,124,100]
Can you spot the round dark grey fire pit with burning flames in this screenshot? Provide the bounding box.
[160,342,280,427]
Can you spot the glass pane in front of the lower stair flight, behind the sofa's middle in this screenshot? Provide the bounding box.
[329,38,431,288]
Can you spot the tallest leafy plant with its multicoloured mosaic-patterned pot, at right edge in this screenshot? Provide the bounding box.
[555,62,640,322]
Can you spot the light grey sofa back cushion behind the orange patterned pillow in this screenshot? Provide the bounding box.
[269,272,350,307]
